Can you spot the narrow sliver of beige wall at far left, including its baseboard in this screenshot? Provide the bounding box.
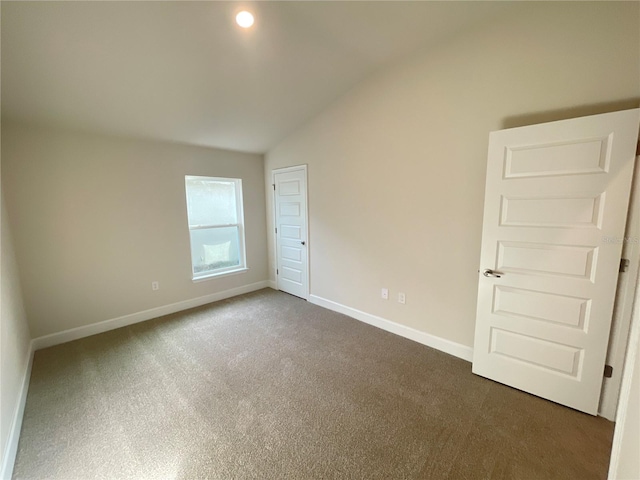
[0,192,31,479]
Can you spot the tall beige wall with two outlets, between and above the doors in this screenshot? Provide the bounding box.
[265,2,640,346]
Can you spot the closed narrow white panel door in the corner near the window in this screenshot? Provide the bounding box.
[273,166,309,300]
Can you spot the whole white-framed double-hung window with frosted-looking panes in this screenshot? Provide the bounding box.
[185,175,246,280]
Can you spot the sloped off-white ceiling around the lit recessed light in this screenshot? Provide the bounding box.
[1,1,514,152]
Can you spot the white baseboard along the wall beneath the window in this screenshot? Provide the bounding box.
[33,280,270,350]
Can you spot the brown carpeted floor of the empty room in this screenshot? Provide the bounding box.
[14,289,613,480]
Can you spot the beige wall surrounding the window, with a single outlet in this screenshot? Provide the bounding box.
[2,122,267,337]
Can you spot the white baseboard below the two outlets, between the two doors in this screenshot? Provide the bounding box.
[309,295,473,362]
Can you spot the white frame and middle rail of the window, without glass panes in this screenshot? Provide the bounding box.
[184,175,249,282]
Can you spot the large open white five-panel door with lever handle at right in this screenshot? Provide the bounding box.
[473,109,640,415]
